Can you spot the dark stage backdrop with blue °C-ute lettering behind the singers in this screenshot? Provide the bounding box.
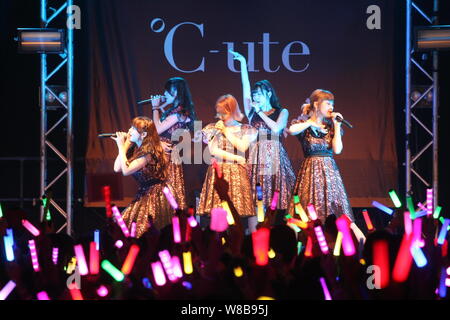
[82,0,397,207]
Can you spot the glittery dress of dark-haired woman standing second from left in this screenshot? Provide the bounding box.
[159,109,192,209]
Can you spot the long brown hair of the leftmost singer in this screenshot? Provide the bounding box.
[127,117,169,180]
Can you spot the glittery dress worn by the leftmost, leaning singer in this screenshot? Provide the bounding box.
[122,160,173,238]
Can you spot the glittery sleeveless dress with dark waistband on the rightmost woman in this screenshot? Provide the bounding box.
[288,120,355,222]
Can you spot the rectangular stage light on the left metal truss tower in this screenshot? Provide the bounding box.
[15,28,66,54]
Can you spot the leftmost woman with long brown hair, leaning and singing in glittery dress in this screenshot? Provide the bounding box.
[112,117,173,237]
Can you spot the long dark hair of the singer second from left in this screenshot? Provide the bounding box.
[161,77,197,130]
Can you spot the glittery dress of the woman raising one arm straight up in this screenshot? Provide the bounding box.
[248,109,295,209]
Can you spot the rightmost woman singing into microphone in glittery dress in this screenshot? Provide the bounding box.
[288,89,354,223]
